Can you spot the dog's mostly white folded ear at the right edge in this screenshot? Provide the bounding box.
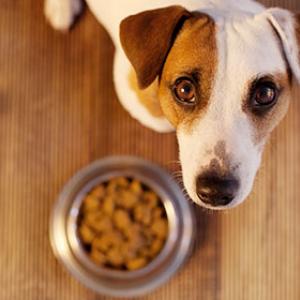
[266,8,300,83]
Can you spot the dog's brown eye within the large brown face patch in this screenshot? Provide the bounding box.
[173,77,196,105]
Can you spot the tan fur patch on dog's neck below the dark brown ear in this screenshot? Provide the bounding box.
[128,70,164,117]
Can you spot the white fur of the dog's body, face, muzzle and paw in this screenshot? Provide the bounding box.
[45,0,300,209]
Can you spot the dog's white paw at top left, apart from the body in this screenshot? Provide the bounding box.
[44,0,82,31]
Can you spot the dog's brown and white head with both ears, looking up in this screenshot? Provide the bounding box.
[120,6,300,209]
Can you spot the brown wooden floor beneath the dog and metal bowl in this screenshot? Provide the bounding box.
[0,0,300,300]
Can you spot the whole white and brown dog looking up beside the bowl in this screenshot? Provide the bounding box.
[45,0,300,210]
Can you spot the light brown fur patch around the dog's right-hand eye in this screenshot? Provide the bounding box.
[243,73,291,145]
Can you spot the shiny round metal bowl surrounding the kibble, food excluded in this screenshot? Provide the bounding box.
[50,156,194,297]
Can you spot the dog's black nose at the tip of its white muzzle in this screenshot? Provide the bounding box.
[196,173,239,207]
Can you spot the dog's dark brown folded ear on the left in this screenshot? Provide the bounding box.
[120,6,191,89]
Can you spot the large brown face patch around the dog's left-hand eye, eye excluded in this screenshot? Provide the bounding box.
[159,13,217,130]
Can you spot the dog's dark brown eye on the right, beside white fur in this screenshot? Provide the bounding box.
[253,82,278,107]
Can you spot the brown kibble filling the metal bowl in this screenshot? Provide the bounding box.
[78,177,168,271]
